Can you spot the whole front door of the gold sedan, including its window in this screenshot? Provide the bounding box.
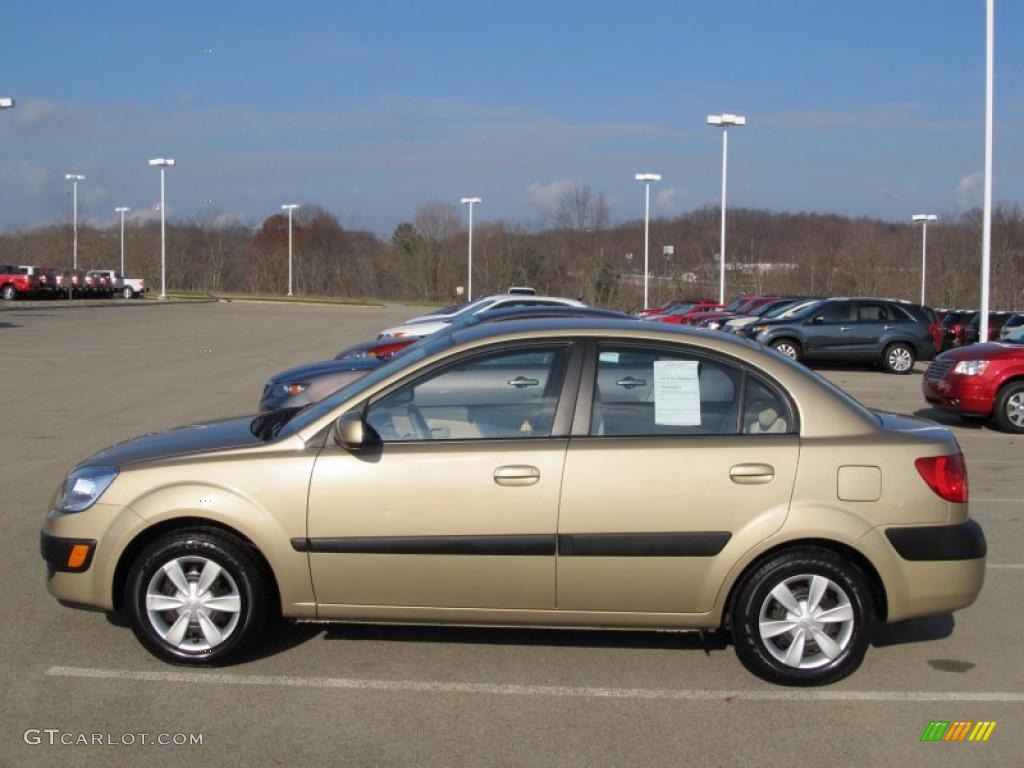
[306,342,582,617]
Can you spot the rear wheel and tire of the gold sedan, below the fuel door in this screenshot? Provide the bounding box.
[732,548,874,685]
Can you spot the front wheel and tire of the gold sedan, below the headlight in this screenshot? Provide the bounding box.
[125,528,267,665]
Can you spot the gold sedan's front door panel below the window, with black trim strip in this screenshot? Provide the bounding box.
[308,439,566,608]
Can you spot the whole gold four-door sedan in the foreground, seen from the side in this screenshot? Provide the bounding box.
[41,317,986,685]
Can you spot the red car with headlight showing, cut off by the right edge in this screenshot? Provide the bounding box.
[921,326,1024,432]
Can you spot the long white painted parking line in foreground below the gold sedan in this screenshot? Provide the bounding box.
[46,667,1024,703]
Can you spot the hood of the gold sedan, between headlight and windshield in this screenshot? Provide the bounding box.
[79,416,263,467]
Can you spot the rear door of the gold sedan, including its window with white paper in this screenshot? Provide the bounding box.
[558,341,799,612]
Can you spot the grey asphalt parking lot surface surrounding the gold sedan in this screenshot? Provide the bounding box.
[0,302,1024,766]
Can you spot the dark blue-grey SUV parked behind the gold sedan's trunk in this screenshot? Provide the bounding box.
[751,298,938,375]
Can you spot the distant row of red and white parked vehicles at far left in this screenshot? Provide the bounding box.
[0,264,148,301]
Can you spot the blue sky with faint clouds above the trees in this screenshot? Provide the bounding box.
[0,0,1024,236]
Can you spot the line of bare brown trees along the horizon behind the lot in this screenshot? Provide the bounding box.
[0,185,1024,309]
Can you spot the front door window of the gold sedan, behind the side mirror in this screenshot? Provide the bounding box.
[367,345,568,442]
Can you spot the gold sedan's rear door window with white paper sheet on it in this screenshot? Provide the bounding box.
[590,345,742,436]
